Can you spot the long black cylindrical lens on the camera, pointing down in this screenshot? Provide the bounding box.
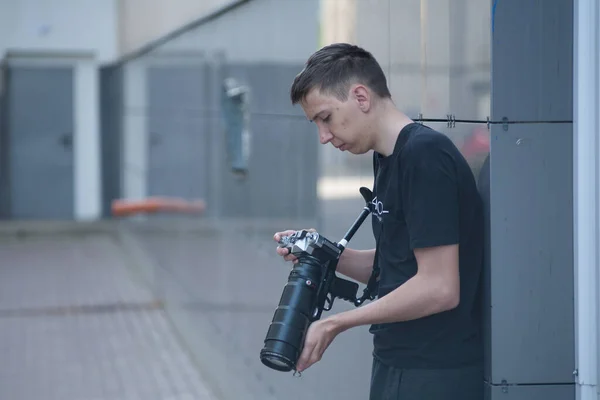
[260,257,322,372]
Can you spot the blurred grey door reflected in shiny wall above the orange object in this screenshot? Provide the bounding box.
[147,66,209,200]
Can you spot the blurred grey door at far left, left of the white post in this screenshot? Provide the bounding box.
[7,67,74,219]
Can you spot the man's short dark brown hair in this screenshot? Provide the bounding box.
[290,43,392,104]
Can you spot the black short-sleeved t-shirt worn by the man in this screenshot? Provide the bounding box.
[370,123,484,368]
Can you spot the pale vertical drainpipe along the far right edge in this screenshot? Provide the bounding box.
[573,0,600,400]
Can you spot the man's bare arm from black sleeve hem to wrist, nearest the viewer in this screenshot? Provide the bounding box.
[330,245,460,332]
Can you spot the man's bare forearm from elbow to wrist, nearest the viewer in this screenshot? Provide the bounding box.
[330,274,457,331]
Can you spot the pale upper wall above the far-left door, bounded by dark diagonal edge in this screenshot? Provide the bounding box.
[0,0,253,64]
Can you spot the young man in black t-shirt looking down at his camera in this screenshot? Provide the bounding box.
[274,44,483,400]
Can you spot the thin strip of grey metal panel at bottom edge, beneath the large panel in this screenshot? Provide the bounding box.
[484,384,575,400]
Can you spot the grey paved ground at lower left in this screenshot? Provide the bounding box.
[0,234,217,400]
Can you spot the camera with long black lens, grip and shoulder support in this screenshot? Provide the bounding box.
[260,187,377,372]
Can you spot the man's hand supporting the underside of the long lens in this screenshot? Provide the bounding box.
[296,318,341,372]
